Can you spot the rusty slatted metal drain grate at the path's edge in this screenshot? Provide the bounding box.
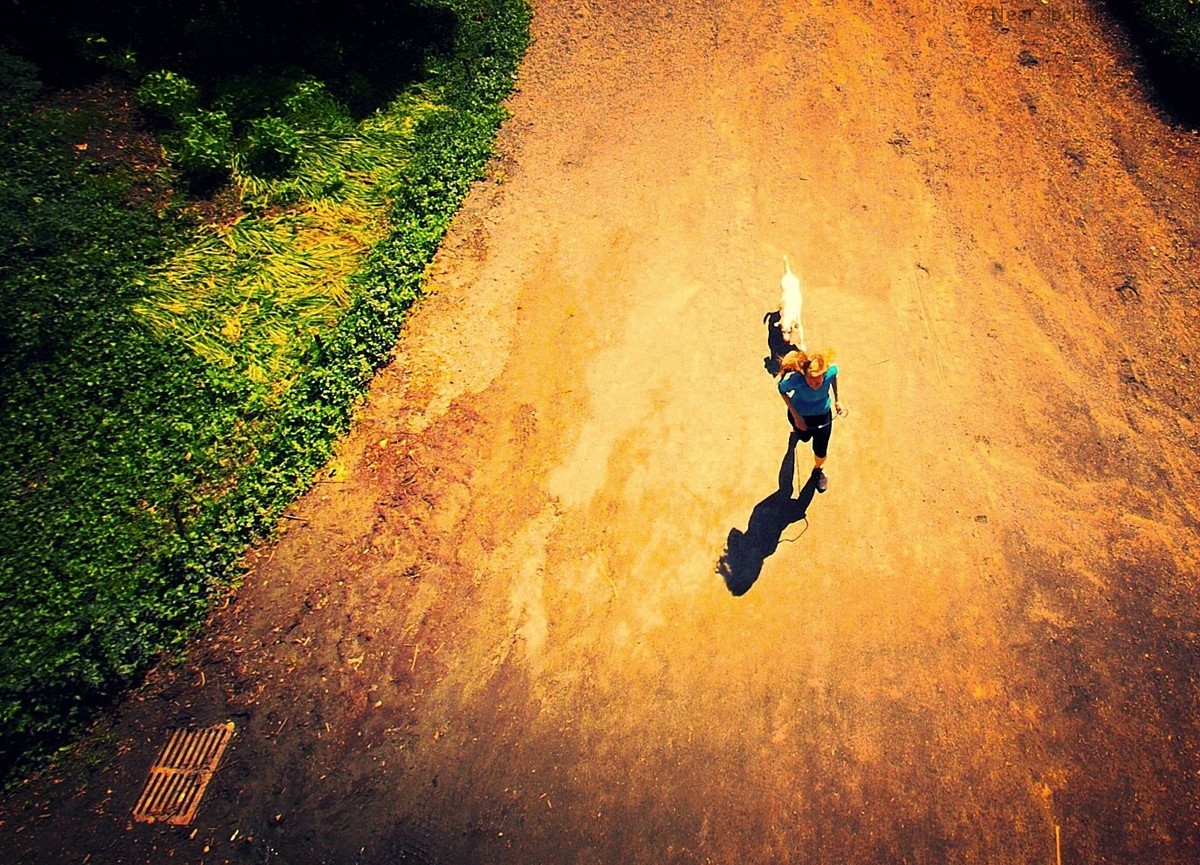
[133,721,233,825]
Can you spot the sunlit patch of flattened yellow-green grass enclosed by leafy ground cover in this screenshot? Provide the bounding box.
[136,89,451,401]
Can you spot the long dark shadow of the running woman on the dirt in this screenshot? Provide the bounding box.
[716,433,817,597]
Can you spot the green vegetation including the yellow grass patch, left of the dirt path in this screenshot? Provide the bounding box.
[0,0,529,774]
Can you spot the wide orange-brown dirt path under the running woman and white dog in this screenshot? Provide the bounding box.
[0,0,1200,865]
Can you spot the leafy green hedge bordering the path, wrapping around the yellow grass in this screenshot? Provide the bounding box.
[0,0,529,775]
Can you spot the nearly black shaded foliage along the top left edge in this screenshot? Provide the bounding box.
[0,0,453,116]
